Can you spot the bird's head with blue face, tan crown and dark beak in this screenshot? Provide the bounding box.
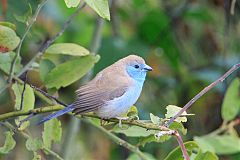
[122,55,152,82]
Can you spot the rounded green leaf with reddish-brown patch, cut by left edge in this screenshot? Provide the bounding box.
[0,25,20,53]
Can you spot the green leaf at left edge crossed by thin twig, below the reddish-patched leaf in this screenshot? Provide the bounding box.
[0,51,22,73]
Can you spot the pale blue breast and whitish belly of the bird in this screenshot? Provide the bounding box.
[96,83,143,118]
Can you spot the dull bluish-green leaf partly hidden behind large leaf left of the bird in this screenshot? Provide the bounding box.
[39,59,56,82]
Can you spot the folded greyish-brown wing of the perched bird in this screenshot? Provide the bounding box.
[73,85,128,114]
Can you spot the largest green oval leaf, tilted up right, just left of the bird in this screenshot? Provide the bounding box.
[44,55,99,89]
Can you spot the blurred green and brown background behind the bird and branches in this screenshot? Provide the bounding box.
[0,0,240,160]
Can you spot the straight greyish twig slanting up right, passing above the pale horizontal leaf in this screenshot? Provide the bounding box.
[17,2,86,77]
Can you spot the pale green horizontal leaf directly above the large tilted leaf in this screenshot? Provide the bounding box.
[45,43,90,56]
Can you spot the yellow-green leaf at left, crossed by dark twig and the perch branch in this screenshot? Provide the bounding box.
[12,83,35,130]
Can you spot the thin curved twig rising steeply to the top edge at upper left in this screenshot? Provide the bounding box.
[8,0,48,83]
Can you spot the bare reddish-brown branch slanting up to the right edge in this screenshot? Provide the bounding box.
[166,63,240,127]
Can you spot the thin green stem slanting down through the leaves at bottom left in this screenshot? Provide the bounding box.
[2,122,63,160]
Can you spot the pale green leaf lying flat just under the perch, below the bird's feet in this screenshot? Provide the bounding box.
[113,125,156,137]
